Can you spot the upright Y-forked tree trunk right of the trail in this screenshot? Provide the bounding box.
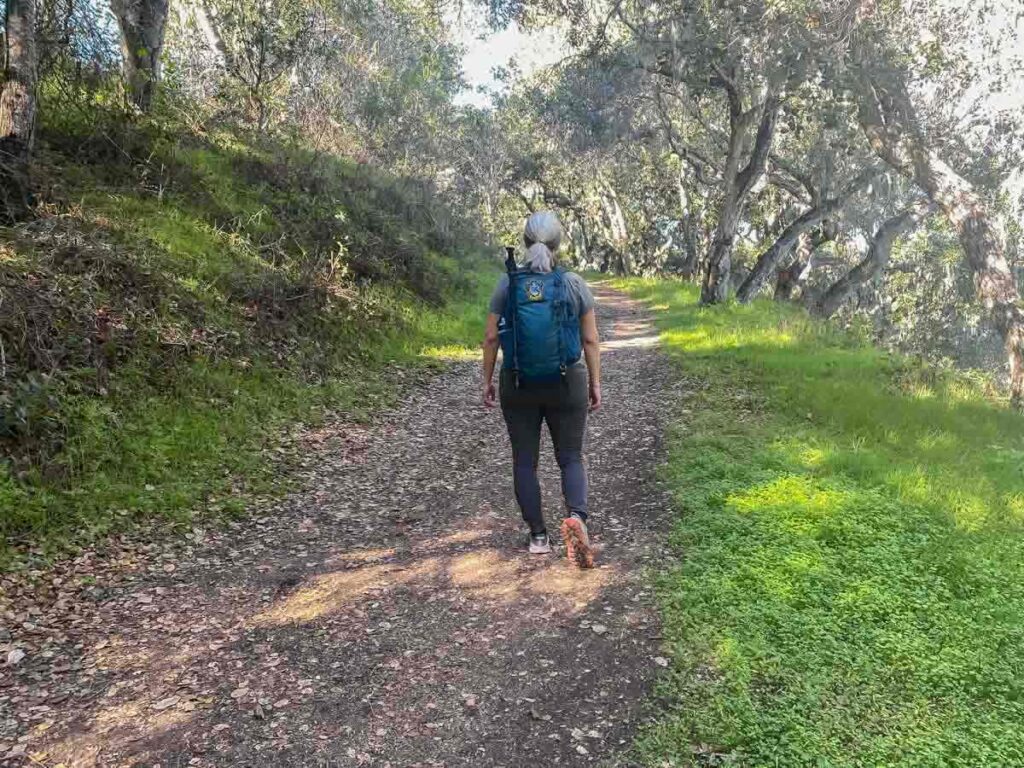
[700,93,779,304]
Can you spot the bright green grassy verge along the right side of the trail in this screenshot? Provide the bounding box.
[614,281,1024,767]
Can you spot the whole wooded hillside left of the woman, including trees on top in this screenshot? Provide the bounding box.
[0,2,493,561]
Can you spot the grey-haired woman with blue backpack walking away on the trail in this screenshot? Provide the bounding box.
[483,211,601,568]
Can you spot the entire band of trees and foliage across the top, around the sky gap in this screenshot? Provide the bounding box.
[8,0,1024,401]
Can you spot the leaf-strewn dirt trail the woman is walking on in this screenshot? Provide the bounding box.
[0,288,673,768]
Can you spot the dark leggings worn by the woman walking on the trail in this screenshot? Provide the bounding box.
[501,366,589,534]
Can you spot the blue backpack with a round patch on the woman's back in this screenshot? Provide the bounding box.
[498,256,583,386]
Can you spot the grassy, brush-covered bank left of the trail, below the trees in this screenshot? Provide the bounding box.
[0,128,487,561]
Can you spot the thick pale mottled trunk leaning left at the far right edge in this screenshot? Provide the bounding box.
[859,69,1024,410]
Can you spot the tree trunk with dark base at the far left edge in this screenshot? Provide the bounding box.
[0,0,39,222]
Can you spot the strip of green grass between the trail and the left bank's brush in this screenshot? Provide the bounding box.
[0,280,489,566]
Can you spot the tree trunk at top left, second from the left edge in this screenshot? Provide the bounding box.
[111,0,168,112]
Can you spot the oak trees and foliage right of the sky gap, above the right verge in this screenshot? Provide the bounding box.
[468,0,1024,399]
